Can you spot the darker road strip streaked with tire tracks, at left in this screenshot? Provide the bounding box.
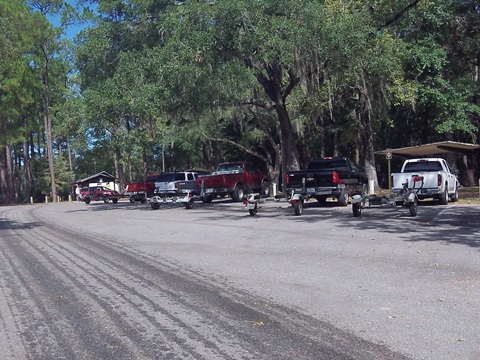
[1,207,412,359]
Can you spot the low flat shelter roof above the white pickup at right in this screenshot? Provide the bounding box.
[375,141,480,158]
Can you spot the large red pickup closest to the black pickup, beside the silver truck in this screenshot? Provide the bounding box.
[195,161,270,203]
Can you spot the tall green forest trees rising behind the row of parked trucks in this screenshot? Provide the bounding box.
[0,0,480,203]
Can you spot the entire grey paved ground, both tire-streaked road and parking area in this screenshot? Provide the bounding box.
[0,200,480,360]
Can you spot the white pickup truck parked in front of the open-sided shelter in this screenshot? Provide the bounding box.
[391,158,459,205]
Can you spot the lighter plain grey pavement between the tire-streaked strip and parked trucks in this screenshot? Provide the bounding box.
[0,199,480,360]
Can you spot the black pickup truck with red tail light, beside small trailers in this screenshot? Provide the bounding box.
[285,157,368,215]
